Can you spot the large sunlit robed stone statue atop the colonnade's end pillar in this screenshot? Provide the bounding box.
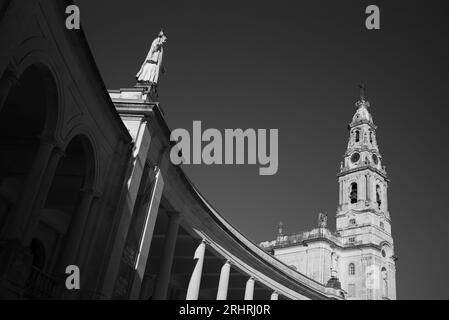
[136,30,167,87]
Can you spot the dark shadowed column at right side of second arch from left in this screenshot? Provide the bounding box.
[58,190,94,272]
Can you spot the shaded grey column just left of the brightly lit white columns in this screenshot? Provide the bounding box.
[153,212,181,300]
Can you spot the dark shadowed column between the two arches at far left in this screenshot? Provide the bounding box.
[2,138,58,238]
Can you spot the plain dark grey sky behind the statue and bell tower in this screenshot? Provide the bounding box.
[76,0,449,299]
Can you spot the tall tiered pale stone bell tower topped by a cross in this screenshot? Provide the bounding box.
[336,86,396,299]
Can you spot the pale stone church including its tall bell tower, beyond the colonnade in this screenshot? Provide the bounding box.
[260,92,397,300]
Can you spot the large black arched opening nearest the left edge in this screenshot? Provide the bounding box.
[0,65,58,233]
